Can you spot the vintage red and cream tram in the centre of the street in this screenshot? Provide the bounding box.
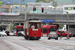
[24,20,41,40]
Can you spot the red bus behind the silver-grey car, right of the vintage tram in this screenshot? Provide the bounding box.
[41,25,57,36]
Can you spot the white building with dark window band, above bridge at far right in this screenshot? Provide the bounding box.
[56,4,75,14]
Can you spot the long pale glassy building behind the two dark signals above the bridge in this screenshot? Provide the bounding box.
[11,3,54,13]
